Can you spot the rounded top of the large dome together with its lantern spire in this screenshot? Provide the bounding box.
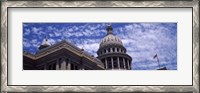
[100,25,123,48]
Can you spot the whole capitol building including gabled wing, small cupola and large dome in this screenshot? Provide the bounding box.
[23,25,132,70]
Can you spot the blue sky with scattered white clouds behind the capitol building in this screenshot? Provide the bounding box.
[23,23,177,70]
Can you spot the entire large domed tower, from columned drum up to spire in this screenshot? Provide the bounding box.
[97,24,132,70]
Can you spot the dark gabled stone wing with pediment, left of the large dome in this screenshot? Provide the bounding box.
[23,40,104,70]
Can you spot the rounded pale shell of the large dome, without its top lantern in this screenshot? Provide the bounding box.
[100,34,123,47]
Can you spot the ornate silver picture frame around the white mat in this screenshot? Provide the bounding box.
[0,0,199,93]
